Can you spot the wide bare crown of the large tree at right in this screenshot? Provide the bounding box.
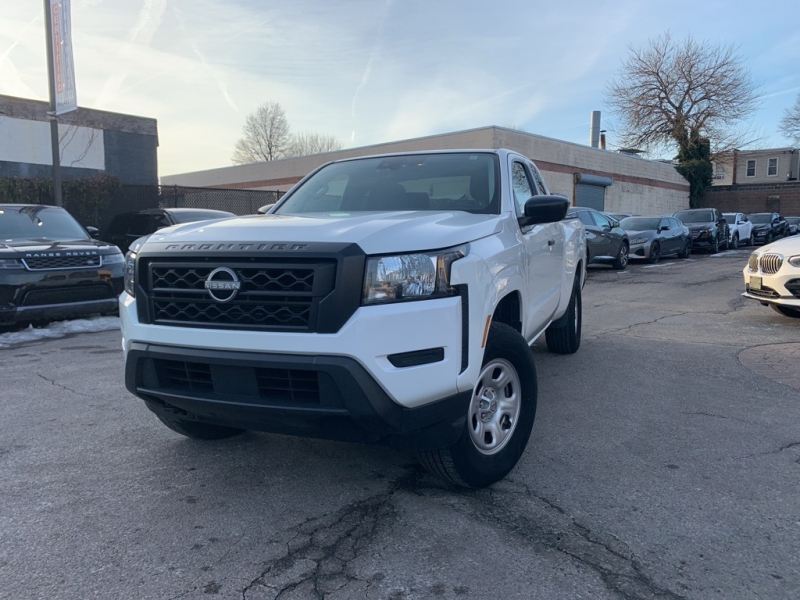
[606,32,758,152]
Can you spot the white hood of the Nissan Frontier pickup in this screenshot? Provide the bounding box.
[147,211,503,254]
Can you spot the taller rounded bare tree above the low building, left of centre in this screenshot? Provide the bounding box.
[231,102,292,165]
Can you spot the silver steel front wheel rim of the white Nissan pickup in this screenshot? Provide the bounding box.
[467,358,522,455]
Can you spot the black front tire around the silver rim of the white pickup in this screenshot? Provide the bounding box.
[418,323,536,488]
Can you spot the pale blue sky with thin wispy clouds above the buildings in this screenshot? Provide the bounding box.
[0,0,800,175]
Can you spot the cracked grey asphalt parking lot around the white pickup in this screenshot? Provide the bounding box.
[0,248,800,600]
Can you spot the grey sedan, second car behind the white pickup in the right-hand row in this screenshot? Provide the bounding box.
[619,216,692,263]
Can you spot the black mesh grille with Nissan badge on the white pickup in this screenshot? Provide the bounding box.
[146,260,336,332]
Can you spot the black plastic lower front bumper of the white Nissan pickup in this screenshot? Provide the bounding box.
[125,342,471,450]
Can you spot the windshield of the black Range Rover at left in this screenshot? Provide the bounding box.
[0,206,91,243]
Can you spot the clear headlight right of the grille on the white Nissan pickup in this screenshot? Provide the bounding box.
[361,245,469,305]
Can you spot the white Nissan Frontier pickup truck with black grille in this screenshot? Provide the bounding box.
[120,150,586,487]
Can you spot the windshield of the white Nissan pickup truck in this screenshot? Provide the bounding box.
[275,152,500,216]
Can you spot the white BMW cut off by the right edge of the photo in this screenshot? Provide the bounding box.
[742,236,800,319]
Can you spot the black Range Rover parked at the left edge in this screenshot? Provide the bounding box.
[0,204,124,325]
